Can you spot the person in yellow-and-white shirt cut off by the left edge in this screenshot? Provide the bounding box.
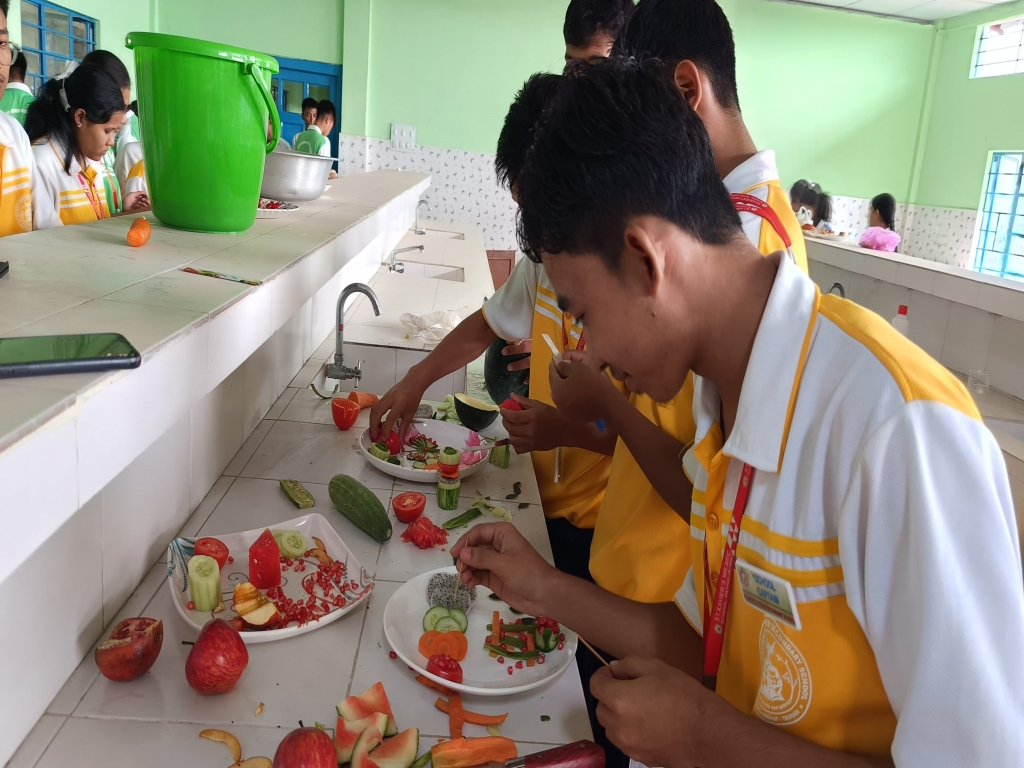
[0,0,52,238]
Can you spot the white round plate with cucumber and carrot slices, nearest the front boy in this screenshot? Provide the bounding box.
[384,566,578,696]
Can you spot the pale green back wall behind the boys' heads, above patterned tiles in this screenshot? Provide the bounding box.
[354,0,934,204]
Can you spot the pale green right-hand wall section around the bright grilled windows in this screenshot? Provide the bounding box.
[914,2,1024,209]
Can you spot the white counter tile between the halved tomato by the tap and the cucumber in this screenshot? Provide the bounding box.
[241,421,392,489]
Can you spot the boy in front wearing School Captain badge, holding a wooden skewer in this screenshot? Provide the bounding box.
[453,60,1024,768]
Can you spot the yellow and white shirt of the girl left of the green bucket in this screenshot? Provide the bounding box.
[32,138,111,229]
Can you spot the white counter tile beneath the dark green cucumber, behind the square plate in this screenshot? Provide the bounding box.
[199,477,391,575]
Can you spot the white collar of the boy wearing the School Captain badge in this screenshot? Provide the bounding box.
[693,255,818,472]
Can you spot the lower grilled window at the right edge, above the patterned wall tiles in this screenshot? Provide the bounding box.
[974,152,1024,280]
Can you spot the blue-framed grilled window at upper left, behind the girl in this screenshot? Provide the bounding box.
[22,0,96,93]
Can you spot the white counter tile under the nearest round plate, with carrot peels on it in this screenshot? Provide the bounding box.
[349,582,592,743]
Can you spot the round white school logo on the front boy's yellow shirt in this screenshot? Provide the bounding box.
[754,618,811,725]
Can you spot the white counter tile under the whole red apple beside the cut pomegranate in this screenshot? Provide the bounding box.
[75,589,366,733]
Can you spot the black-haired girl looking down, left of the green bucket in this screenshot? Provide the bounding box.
[25,63,147,228]
